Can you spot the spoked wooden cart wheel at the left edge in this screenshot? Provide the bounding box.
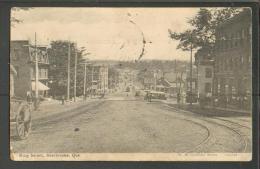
[16,104,31,139]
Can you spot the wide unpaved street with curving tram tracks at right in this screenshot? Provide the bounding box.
[10,92,252,153]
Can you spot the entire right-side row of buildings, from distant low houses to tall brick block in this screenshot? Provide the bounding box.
[141,9,252,109]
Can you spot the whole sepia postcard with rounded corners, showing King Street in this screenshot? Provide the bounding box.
[10,7,252,161]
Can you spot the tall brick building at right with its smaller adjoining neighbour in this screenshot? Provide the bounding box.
[195,10,252,109]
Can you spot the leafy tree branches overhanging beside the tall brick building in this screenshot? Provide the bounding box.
[168,8,241,52]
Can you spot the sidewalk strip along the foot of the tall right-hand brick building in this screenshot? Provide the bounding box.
[167,103,252,117]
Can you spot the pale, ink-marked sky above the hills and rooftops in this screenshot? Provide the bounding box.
[11,7,199,61]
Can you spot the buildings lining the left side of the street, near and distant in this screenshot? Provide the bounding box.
[10,40,109,98]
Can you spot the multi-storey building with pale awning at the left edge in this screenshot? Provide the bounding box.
[10,40,49,98]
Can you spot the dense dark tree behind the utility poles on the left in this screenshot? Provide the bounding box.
[48,40,85,96]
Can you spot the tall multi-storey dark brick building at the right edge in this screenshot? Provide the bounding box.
[213,9,252,109]
